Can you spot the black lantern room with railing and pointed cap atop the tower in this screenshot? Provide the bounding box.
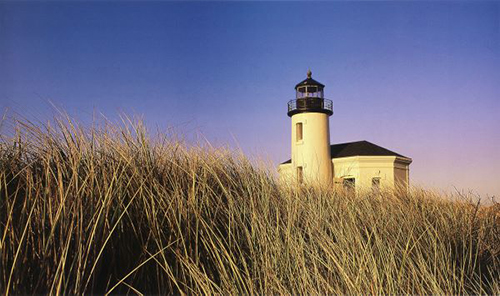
[288,70,333,117]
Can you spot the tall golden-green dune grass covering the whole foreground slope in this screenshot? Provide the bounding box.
[0,118,500,294]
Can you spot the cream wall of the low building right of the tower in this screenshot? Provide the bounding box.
[332,156,411,192]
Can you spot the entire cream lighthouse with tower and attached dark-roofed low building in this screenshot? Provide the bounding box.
[278,71,412,192]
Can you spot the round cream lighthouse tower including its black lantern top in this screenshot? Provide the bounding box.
[288,70,333,186]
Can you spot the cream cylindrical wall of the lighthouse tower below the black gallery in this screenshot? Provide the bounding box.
[291,112,332,185]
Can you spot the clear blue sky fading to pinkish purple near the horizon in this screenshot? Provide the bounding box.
[0,1,500,197]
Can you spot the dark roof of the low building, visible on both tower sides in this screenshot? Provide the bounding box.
[282,141,408,164]
